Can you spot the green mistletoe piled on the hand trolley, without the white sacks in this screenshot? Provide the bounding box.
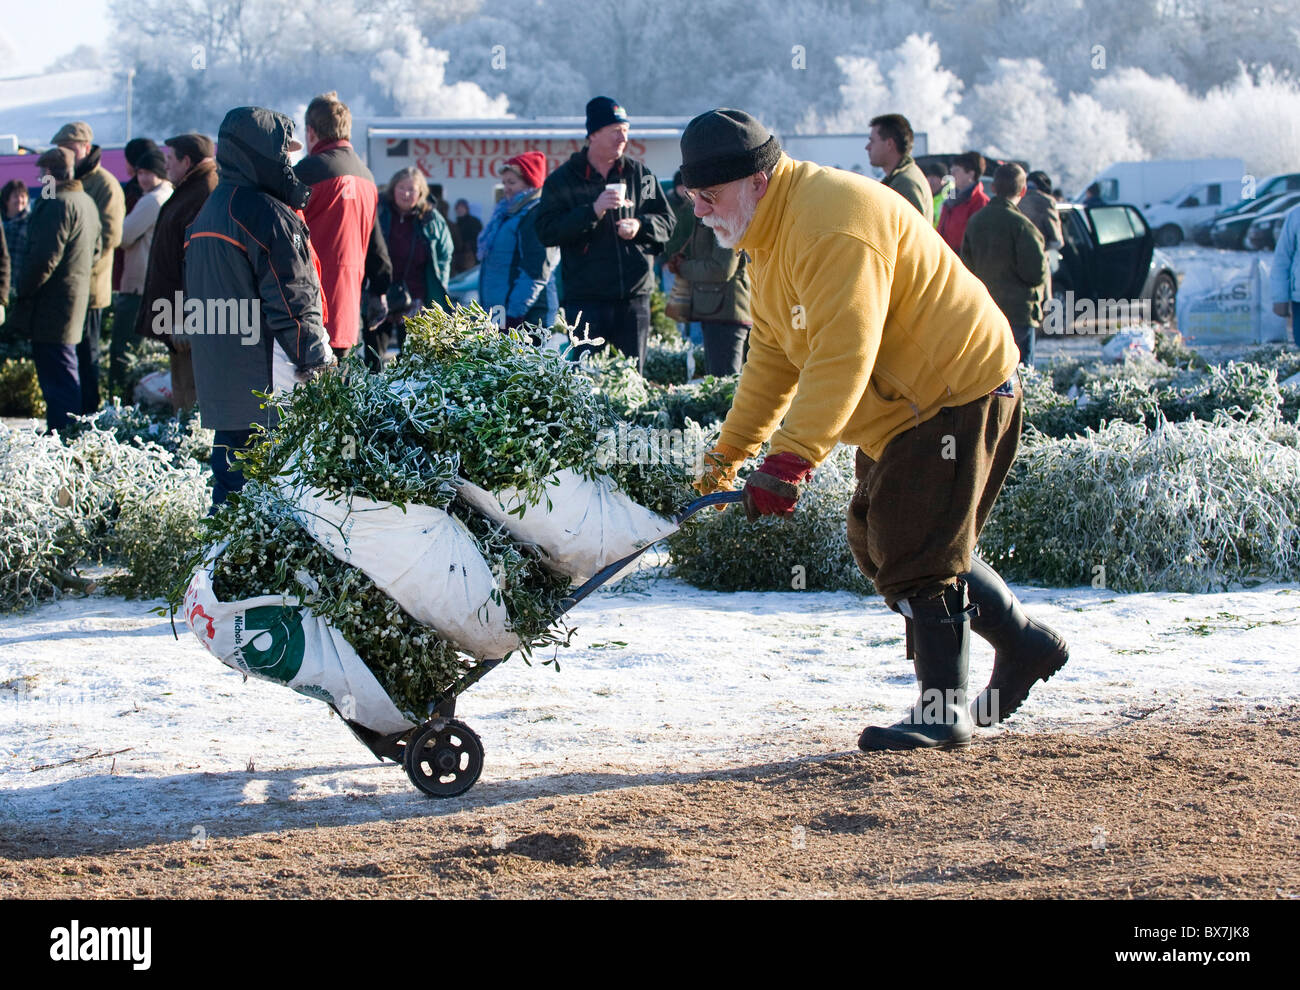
[170,308,694,717]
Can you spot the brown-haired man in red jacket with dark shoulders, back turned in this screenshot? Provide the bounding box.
[294,92,393,360]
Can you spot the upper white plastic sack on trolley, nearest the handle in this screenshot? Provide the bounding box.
[458,468,677,583]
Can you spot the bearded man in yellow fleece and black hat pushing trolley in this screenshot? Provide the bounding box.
[681,109,1069,752]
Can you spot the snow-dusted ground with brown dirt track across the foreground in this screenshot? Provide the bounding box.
[0,581,1300,898]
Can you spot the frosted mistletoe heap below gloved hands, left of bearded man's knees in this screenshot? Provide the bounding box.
[668,444,871,592]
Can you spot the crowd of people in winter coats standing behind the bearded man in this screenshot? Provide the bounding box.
[0,92,1076,503]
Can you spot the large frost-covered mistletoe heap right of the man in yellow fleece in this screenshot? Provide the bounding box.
[980,413,1300,591]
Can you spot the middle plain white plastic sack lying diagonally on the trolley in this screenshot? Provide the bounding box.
[281,485,521,660]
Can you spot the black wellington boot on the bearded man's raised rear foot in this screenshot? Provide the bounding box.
[963,555,1070,726]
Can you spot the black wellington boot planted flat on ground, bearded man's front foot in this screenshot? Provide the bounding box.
[858,581,972,752]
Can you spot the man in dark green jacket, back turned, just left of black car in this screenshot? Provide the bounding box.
[962,164,1048,366]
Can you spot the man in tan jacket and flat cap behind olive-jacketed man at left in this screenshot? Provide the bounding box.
[49,121,127,416]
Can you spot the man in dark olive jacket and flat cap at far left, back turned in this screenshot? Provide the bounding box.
[13,147,100,430]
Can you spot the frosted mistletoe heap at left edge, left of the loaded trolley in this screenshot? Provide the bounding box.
[0,418,211,611]
